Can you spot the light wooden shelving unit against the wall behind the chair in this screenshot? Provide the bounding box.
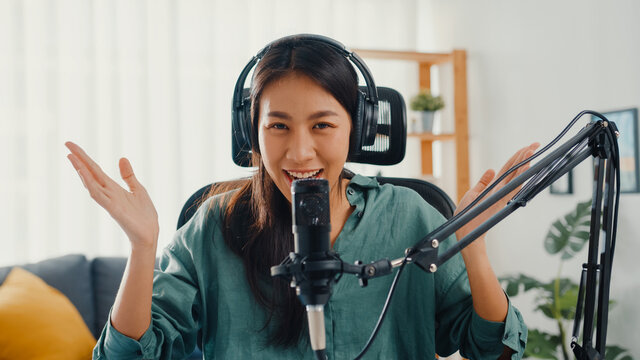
[352,49,469,200]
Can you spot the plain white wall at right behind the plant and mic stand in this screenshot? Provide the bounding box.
[418,0,640,357]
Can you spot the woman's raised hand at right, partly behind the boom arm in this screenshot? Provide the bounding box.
[456,143,540,260]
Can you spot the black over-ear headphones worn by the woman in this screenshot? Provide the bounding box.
[231,34,378,167]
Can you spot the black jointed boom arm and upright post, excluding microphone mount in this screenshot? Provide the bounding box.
[408,111,620,359]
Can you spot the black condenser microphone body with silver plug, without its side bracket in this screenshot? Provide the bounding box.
[291,179,335,359]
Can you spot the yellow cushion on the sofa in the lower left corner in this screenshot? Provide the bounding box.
[0,267,96,359]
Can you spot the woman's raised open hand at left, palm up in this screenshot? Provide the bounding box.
[65,141,159,250]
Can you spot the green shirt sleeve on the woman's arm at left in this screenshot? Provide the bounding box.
[93,211,210,359]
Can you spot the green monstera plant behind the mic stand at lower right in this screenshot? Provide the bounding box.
[500,200,632,360]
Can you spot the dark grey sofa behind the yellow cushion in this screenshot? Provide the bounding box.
[0,255,202,359]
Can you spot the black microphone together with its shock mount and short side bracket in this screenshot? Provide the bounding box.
[271,179,398,360]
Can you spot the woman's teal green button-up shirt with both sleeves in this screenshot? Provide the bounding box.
[94,175,527,360]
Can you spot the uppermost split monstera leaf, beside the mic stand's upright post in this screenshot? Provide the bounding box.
[544,200,591,260]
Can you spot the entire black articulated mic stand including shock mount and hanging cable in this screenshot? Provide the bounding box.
[271,110,620,359]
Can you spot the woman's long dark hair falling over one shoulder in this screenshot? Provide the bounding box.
[213,38,358,347]
